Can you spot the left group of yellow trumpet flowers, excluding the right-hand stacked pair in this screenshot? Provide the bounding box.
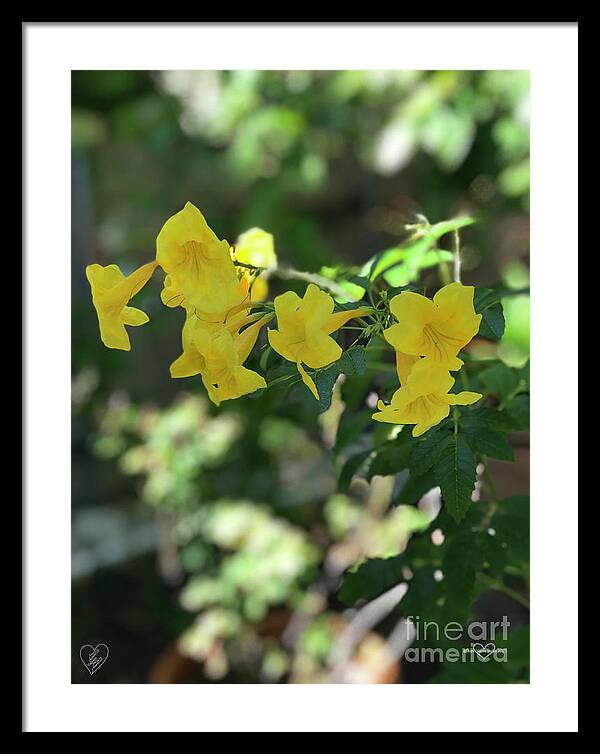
[86,202,364,405]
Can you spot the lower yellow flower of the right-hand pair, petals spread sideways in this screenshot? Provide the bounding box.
[373,358,482,437]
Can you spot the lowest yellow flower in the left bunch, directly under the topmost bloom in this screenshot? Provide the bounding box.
[171,314,272,406]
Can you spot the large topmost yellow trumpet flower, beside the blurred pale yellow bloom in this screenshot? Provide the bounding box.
[156,202,243,314]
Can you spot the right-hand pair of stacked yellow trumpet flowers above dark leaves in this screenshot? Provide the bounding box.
[373,283,482,437]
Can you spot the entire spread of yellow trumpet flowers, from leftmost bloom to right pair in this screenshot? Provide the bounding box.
[86,202,481,437]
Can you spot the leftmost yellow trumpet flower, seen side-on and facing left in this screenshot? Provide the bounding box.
[85,262,156,351]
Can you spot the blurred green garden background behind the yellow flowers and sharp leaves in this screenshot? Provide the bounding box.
[71,70,529,683]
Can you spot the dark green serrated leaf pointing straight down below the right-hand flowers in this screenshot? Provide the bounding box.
[435,434,477,523]
